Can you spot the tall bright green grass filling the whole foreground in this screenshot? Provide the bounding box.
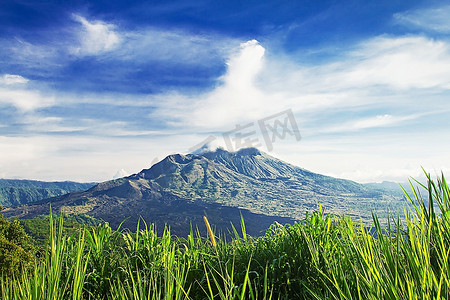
[0,172,450,299]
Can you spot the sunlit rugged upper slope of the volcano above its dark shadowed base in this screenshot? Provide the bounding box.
[134,148,398,218]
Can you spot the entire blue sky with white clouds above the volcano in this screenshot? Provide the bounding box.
[0,0,450,182]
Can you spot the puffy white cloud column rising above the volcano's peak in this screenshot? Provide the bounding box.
[151,40,286,131]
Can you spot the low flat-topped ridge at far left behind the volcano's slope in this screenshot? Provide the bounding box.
[0,179,95,207]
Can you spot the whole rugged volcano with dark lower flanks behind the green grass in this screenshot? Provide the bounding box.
[2,148,404,234]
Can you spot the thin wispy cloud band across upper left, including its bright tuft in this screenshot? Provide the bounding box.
[0,20,241,84]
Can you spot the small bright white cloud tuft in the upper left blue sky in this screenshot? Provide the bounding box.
[72,15,121,56]
